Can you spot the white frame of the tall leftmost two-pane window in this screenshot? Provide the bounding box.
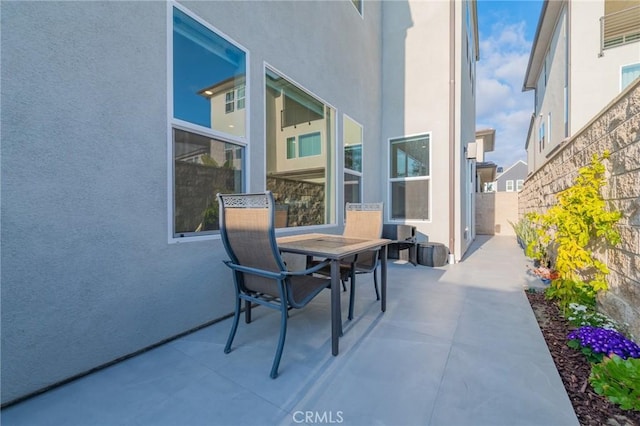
[166,1,251,244]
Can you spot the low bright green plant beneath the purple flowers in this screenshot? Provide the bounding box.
[589,355,640,411]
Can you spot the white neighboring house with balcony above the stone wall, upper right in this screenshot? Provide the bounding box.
[523,0,640,173]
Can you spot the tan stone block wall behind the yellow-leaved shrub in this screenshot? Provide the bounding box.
[519,80,640,337]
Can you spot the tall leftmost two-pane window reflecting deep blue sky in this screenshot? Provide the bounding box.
[170,6,246,238]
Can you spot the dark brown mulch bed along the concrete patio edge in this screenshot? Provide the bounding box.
[527,292,640,426]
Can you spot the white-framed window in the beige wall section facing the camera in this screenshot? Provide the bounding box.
[389,134,431,220]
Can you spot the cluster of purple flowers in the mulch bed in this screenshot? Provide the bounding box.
[567,326,640,363]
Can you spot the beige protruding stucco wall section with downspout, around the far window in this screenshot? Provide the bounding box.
[380,0,475,260]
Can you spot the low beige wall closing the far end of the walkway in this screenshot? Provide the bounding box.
[475,192,519,235]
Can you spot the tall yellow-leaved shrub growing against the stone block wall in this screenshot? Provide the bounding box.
[527,151,622,312]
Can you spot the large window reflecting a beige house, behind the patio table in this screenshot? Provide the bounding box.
[265,68,335,226]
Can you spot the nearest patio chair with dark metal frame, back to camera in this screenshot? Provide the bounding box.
[218,191,329,379]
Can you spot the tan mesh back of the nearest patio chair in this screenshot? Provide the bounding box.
[218,191,286,297]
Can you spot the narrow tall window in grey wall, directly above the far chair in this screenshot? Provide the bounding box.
[342,115,363,203]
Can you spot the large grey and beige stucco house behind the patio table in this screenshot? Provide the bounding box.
[0,0,479,403]
